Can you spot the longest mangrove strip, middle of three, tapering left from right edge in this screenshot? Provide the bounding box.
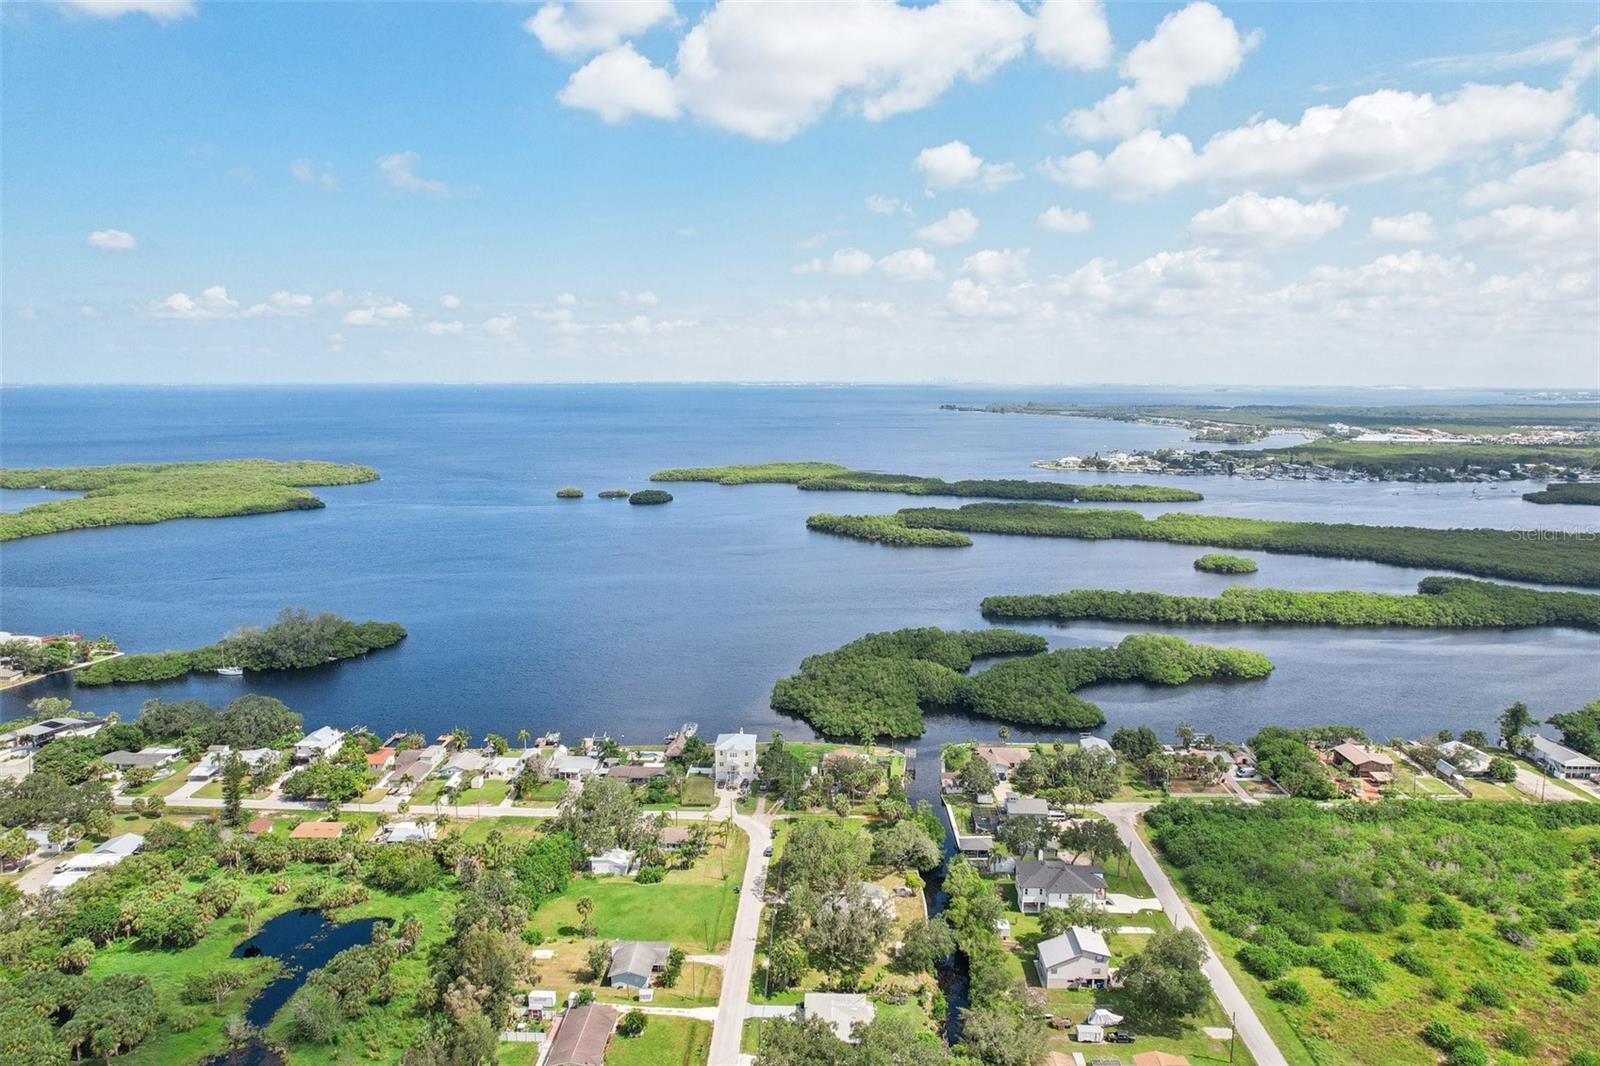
[806,503,1600,587]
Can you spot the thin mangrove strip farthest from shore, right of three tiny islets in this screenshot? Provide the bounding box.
[650,463,1203,503]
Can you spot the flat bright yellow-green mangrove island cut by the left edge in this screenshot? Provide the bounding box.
[0,459,378,541]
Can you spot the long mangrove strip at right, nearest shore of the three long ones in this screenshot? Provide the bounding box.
[982,578,1600,629]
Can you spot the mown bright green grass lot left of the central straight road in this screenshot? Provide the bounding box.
[533,831,750,954]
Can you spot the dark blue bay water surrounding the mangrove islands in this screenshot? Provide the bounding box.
[0,386,1600,744]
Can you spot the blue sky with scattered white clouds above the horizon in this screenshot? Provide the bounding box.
[0,0,1600,387]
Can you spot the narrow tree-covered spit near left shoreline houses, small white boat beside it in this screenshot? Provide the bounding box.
[75,610,405,685]
